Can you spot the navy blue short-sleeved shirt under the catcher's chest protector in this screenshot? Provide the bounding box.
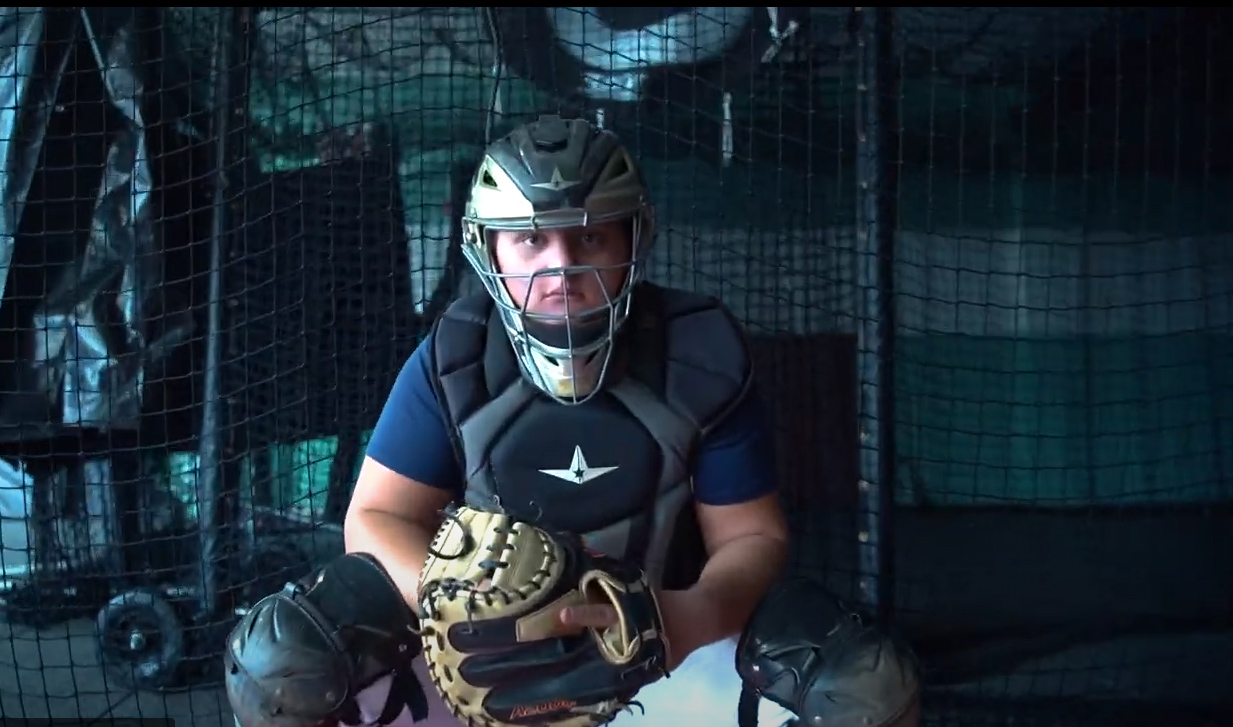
[367,336,776,505]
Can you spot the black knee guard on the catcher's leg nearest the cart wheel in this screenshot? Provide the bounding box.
[223,553,428,727]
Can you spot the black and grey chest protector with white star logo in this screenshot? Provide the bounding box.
[433,283,752,588]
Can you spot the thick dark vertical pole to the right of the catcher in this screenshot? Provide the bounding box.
[854,7,898,625]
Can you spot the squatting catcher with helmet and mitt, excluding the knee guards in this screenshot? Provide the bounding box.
[344,115,792,727]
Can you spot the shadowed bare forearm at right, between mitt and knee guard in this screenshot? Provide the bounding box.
[667,535,788,658]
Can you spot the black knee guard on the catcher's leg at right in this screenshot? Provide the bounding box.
[736,579,920,727]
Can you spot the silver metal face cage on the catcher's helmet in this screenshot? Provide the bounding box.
[464,208,653,404]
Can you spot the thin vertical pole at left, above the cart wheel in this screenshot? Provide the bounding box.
[197,7,250,620]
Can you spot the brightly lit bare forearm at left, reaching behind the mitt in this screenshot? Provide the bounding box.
[343,510,433,606]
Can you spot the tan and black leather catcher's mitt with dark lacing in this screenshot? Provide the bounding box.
[419,506,667,727]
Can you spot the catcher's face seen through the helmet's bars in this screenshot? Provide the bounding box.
[492,221,633,322]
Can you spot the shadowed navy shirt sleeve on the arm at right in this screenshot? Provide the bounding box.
[693,392,778,505]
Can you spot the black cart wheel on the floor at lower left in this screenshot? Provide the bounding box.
[95,590,184,691]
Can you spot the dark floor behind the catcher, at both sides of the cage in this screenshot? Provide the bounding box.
[0,513,1233,727]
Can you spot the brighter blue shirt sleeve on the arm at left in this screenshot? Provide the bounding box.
[367,335,462,492]
